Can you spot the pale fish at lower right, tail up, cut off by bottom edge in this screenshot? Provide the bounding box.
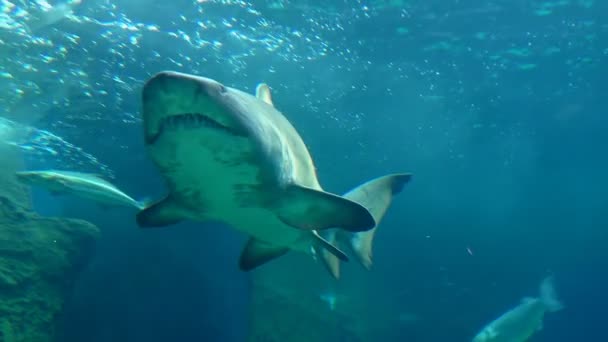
[473,277,563,342]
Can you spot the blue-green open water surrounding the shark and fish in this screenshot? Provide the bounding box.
[0,0,608,342]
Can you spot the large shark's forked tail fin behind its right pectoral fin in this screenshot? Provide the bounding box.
[340,173,412,269]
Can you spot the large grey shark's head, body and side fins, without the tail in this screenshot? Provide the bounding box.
[137,71,410,271]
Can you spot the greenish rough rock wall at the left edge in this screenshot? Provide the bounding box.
[0,142,99,342]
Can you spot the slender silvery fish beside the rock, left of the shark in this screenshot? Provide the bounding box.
[16,170,146,209]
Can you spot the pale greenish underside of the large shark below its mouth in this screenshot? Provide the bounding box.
[152,134,312,251]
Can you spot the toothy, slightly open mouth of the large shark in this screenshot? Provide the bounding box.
[147,113,242,144]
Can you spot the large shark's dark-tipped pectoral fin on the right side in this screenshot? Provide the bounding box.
[274,185,376,232]
